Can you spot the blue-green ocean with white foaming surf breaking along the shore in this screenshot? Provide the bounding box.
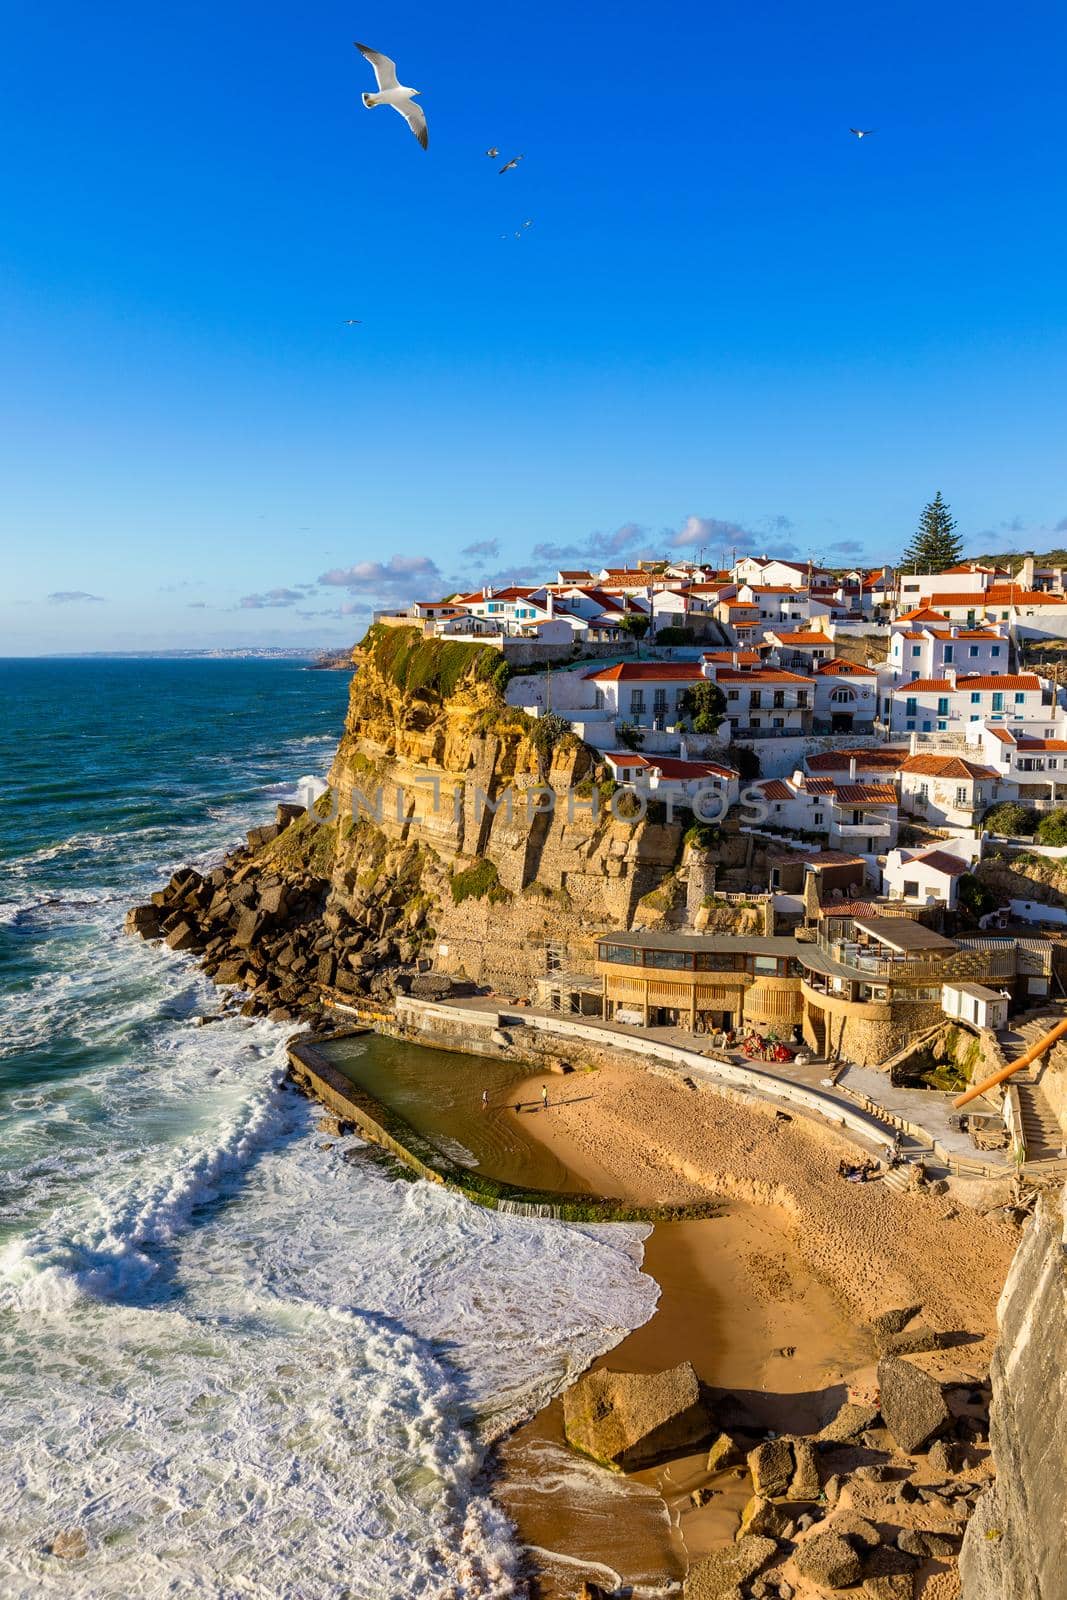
[0,659,657,1600]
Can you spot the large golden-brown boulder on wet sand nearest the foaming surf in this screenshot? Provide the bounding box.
[563,1362,710,1472]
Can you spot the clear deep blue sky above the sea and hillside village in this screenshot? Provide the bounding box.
[0,0,1067,654]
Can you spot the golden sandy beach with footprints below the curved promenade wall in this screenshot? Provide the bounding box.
[498,1062,1017,1600]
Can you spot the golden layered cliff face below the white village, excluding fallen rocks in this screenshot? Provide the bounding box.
[313,627,683,984]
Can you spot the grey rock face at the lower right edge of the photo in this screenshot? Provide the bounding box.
[960,1197,1067,1600]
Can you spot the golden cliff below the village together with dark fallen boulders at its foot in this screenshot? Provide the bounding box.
[130,627,716,1013]
